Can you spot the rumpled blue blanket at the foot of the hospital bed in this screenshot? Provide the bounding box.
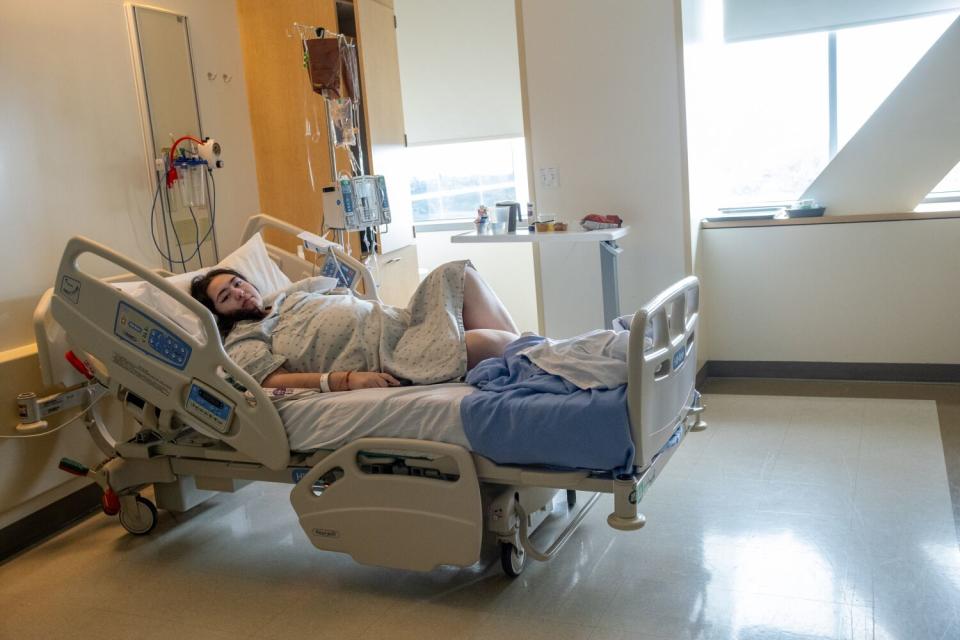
[460,336,635,472]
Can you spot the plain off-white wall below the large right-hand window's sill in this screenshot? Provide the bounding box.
[700,219,960,364]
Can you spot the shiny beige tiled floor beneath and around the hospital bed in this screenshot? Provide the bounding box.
[0,395,960,640]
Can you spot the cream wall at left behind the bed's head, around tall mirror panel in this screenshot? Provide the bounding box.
[0,0,258,528]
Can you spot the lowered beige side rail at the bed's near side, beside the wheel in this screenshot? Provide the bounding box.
[290,438,483,571]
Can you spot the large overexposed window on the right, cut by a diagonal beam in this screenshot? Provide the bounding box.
[684,12,960,212]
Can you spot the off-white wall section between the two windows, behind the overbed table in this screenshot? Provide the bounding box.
[520,0,690,312]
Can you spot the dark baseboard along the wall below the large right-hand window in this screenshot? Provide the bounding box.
[697,360,960,384]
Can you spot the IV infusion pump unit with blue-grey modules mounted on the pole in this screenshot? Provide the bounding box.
[323,176,391,231]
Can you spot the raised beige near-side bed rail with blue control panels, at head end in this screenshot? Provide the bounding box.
[50,237,290,469]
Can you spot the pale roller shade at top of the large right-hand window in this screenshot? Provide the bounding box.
[724,0,960,42]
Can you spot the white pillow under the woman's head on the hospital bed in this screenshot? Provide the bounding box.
[114,233,292,336]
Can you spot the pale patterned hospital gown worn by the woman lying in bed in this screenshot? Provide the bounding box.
[224,261,469,384]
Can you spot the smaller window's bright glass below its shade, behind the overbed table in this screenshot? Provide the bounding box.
[408,138,529,222]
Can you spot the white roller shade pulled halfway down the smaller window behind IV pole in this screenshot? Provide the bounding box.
[395,0,520,145]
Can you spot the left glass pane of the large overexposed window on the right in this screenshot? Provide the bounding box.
[684,33,829,209]
